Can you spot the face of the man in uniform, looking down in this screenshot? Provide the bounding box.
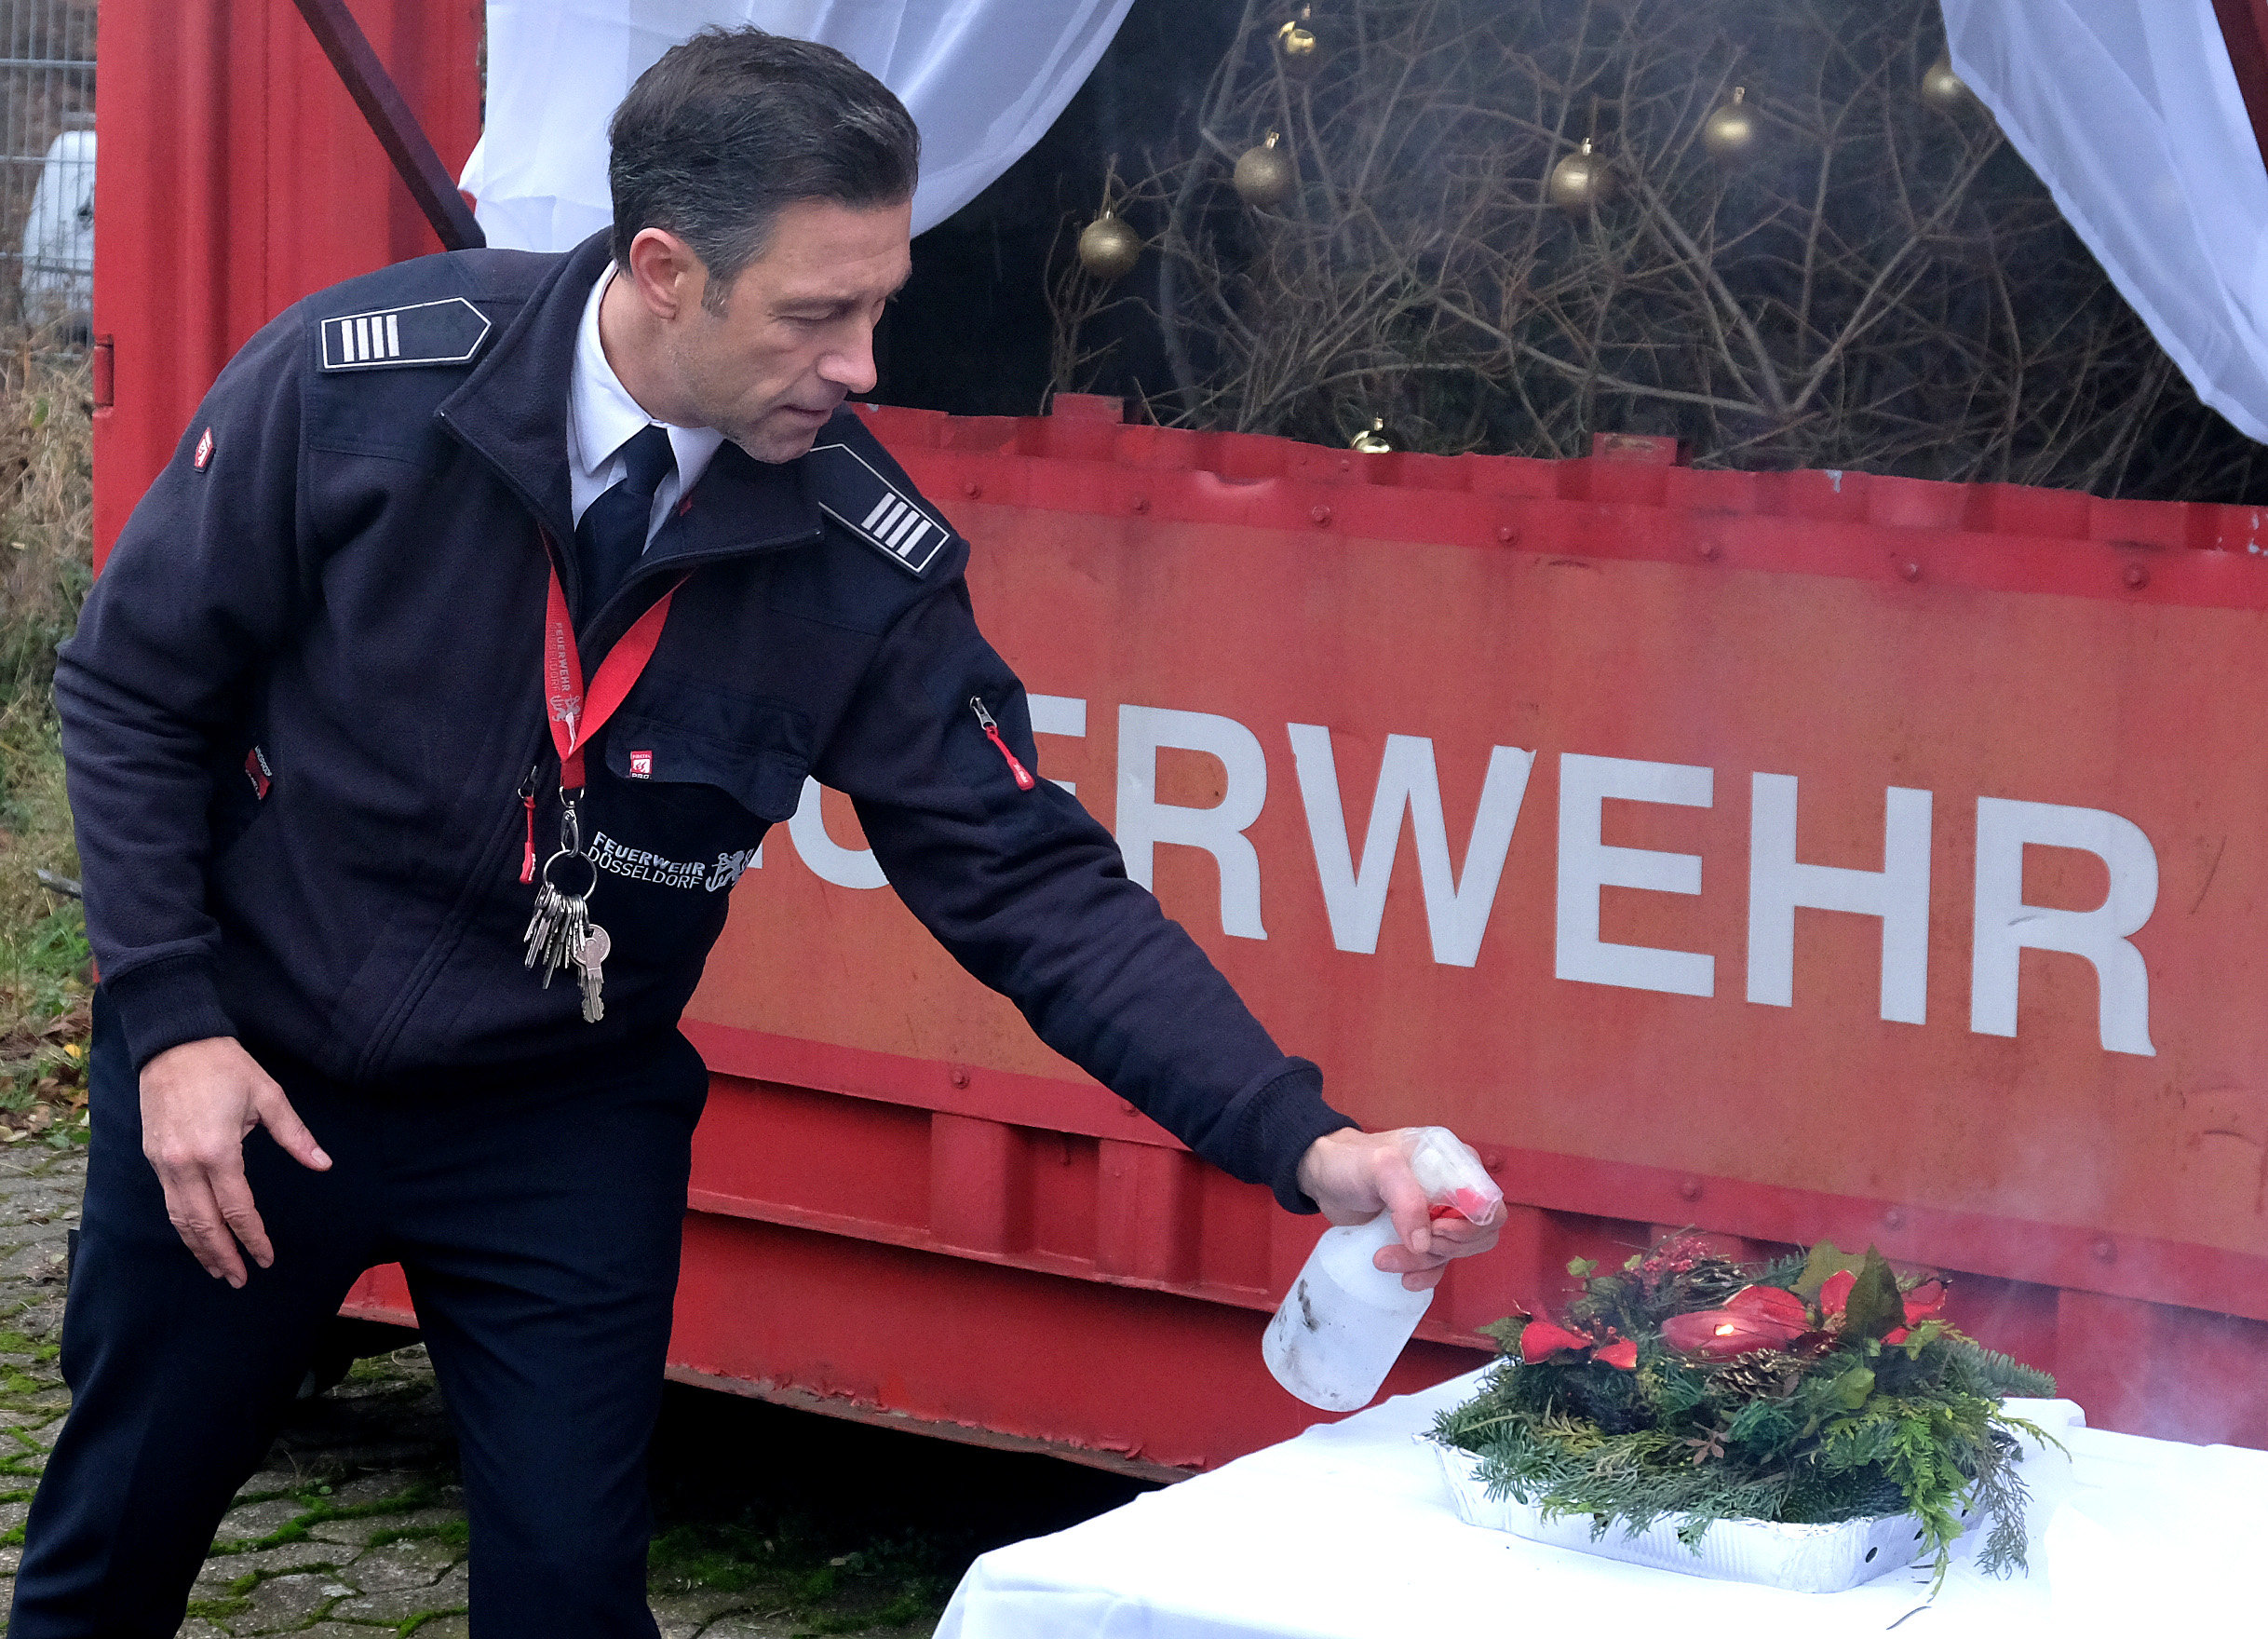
[662,200,914,461]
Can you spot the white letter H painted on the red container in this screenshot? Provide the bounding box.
[1748,774,1930,1023]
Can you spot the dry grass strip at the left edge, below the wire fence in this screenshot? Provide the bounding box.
[0,343,93,1145]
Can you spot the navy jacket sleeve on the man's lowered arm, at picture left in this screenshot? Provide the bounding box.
[54,309,306,1067]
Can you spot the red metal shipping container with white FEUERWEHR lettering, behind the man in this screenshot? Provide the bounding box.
[95,0,2268,1471]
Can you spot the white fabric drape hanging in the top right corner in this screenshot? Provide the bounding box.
[1944,0,2268,438]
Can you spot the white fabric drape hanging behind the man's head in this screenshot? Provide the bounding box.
[463,0,1134,250]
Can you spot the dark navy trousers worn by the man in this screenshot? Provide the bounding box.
[9,996,708,1639]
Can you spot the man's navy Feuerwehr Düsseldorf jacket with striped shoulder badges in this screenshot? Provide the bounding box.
[57,237,1349,1208]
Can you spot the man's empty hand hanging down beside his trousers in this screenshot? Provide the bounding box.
[141,1036,331,1287]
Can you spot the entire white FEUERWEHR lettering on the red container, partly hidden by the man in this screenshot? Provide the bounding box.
[749,695,2157,1056]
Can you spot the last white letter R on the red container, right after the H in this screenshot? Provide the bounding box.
[1968,797,2157,1058]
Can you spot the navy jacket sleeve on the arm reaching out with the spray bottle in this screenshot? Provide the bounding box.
[815,583,1354,1212]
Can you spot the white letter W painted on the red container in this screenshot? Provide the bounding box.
[1286,722,1535,967]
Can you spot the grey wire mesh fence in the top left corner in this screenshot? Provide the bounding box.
[0,0,95,341]
